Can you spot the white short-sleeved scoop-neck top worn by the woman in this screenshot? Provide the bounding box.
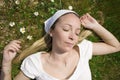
[21,40,92,80]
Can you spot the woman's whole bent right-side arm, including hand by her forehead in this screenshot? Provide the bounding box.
[80,14,120,55]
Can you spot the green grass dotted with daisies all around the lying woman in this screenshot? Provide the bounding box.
[0,0,120,80]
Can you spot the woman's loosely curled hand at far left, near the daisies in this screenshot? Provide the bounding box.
[3,40,21,64]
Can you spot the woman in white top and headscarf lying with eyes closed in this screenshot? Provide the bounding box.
[2,10,120,80]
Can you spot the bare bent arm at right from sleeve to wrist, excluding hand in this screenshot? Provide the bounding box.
[93,26,120,55]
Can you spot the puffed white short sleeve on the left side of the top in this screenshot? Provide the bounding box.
[20,57,35,79]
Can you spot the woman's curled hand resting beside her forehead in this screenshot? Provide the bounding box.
[80,13,100,29]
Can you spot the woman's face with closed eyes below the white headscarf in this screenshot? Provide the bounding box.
[50,14,81,52]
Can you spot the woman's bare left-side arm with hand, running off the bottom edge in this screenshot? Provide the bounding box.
[1,40,29,80]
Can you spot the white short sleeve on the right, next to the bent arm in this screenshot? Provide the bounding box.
[78,39,93,60]
